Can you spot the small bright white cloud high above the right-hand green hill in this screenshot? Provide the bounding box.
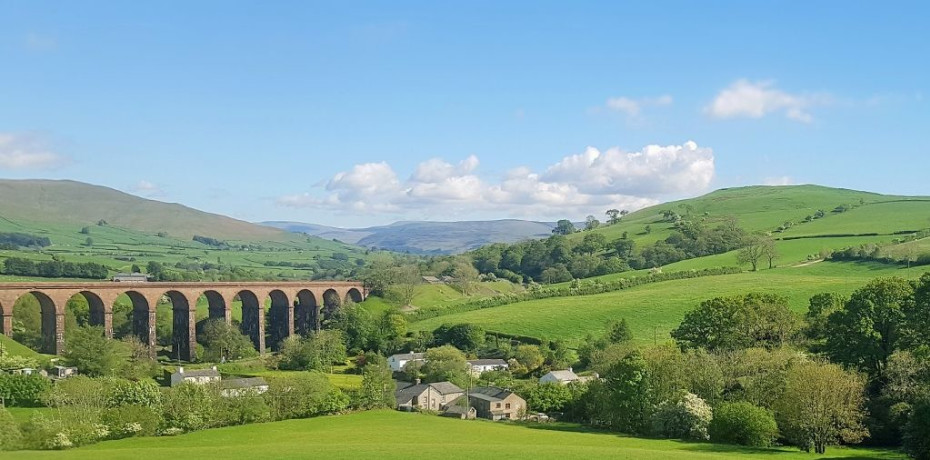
[704,79,830,123]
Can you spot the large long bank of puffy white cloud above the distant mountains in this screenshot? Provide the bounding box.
[277,141,714,219]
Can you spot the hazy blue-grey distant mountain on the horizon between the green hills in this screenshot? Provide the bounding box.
[262,219,555,254]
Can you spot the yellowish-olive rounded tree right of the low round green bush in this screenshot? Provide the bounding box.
[775,362,868,455]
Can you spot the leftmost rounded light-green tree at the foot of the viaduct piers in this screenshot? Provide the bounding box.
[64,326,123,377]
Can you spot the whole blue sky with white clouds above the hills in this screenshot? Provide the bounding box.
[0,0,930,226]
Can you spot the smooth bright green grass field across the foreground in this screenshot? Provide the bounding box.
[4,411,904,460]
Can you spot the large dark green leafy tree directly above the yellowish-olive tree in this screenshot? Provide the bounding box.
[824,278,913,377]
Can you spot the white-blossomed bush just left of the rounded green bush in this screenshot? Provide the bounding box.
[652,391,713,441]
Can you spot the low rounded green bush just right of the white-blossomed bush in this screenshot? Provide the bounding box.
[710,401,778,447]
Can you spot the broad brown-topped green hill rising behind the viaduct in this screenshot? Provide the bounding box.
[0,180,367,281]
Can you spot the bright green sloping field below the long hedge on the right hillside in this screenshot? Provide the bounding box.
[411,262,908,342]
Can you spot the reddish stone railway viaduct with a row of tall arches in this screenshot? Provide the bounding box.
[0,281,367,361]
